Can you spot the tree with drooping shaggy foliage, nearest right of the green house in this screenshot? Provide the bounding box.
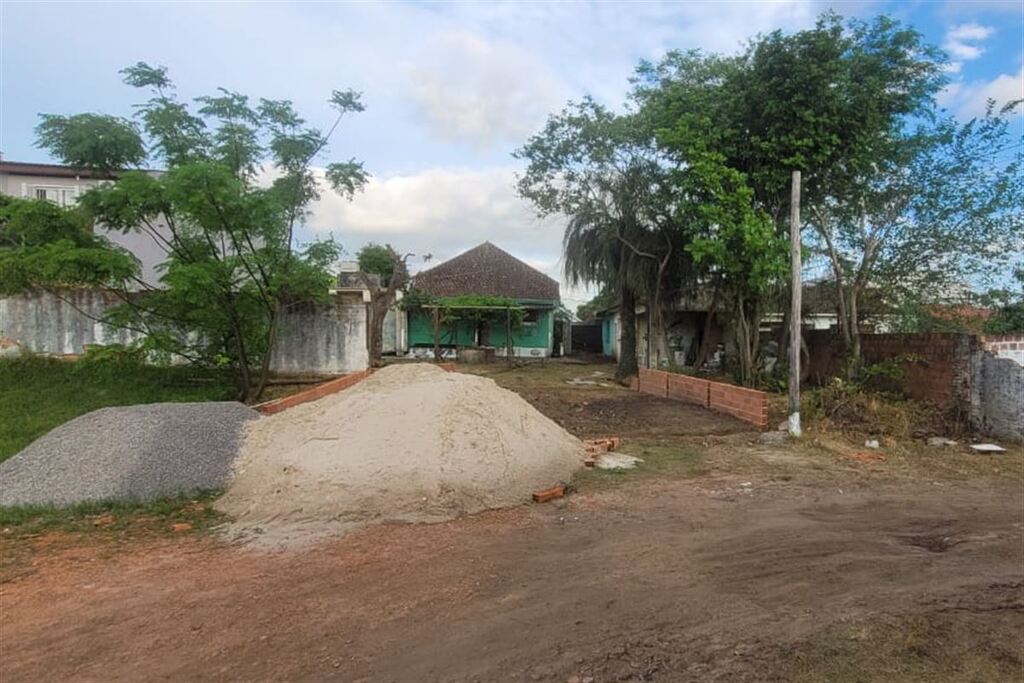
[515,98,679,379]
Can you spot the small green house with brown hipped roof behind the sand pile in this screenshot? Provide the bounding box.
[407,242,562,357]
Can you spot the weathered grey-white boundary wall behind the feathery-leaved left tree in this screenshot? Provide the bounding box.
[0,289,369,374]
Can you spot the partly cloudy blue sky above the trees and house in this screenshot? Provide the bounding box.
[0,0,1024,308]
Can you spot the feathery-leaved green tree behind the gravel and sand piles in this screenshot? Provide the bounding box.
[20,62,368,399]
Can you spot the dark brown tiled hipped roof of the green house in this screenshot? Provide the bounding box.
[413,242,559,301]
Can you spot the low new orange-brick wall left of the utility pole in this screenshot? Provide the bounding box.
[637,368,768,429]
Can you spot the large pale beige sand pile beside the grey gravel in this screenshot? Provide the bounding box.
[218,365,583,544]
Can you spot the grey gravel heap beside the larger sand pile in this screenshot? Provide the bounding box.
[0,401,258,506]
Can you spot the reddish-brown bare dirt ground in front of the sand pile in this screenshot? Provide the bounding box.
[0,364,1024,683]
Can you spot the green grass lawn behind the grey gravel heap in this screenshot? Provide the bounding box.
[0,356,234,462]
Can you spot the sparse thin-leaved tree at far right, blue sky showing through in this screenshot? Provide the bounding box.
[810,103,1024,372]
